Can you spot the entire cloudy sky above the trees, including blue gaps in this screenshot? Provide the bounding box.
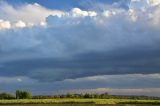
[0,0,160,97]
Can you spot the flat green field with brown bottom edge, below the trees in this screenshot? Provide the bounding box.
[0,99,160,106]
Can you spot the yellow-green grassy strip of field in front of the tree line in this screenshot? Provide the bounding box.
[0,99,160,105]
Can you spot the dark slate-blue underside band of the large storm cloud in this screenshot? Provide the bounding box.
[0,47,160,81]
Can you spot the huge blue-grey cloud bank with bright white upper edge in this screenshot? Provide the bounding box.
[0,1,160,82]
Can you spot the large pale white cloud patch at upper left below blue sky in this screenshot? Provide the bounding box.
[0,1,65,26]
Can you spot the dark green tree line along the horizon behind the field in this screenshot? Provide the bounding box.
[0,90,160,100]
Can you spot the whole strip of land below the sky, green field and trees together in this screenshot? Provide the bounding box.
[0,90,160,105]
